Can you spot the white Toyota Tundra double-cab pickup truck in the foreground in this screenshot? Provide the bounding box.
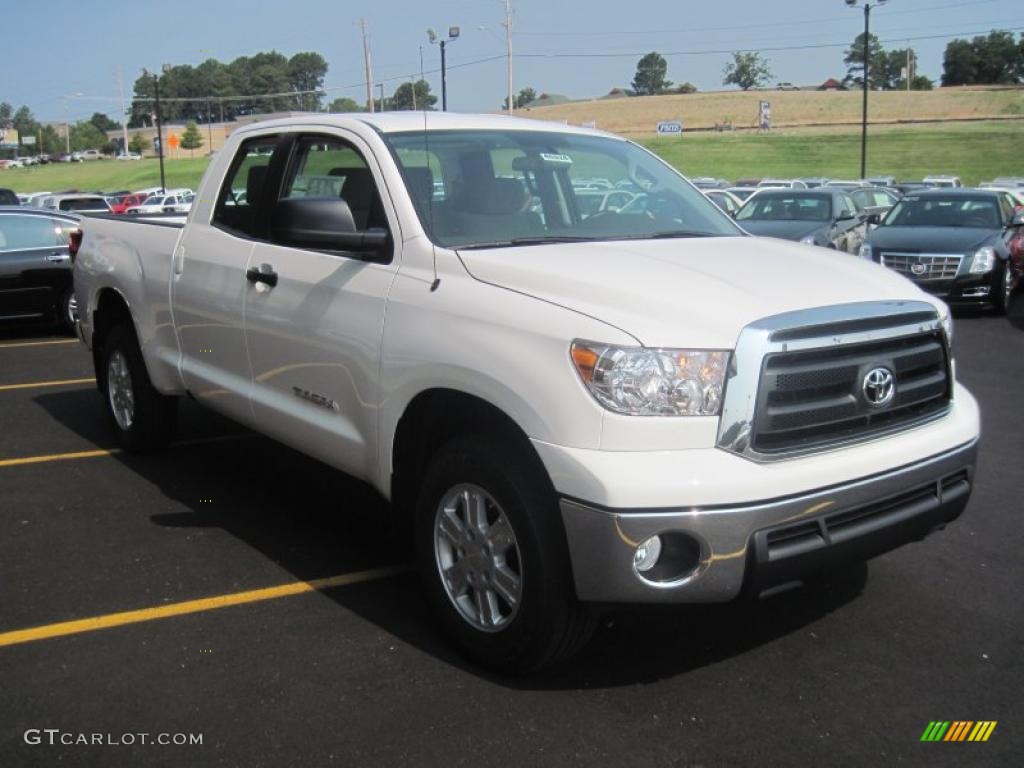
[75,113,979,672]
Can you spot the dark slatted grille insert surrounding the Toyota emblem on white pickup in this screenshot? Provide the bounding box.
[751,330,950,454]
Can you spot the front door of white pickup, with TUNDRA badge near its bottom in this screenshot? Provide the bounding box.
[246,132,401,477]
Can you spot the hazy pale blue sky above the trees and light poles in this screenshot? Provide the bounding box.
[0,0,1024,121]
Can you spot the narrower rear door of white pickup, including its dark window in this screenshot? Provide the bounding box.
[171,133,282,423]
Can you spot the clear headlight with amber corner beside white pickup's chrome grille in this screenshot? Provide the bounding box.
[571,341,729,416]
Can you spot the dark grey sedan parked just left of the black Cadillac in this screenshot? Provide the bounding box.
[736,188,867,253]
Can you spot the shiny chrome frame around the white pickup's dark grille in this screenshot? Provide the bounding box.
[717,301,952,462]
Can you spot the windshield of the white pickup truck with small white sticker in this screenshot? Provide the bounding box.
[384,130,741,248]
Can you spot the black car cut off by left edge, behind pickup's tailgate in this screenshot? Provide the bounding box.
[0,206,78,331]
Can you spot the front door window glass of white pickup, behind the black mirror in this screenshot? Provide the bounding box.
[281,136,387,231]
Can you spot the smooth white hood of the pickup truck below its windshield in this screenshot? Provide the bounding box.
[459,237,941,349]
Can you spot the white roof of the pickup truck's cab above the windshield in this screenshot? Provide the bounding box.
[239,111,622,138]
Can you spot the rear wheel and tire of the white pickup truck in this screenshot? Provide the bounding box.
[96,325,178,453]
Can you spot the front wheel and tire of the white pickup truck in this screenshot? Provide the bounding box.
[414,435,595,675]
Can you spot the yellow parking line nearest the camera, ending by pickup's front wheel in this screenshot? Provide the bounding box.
[0,565,410,646]
